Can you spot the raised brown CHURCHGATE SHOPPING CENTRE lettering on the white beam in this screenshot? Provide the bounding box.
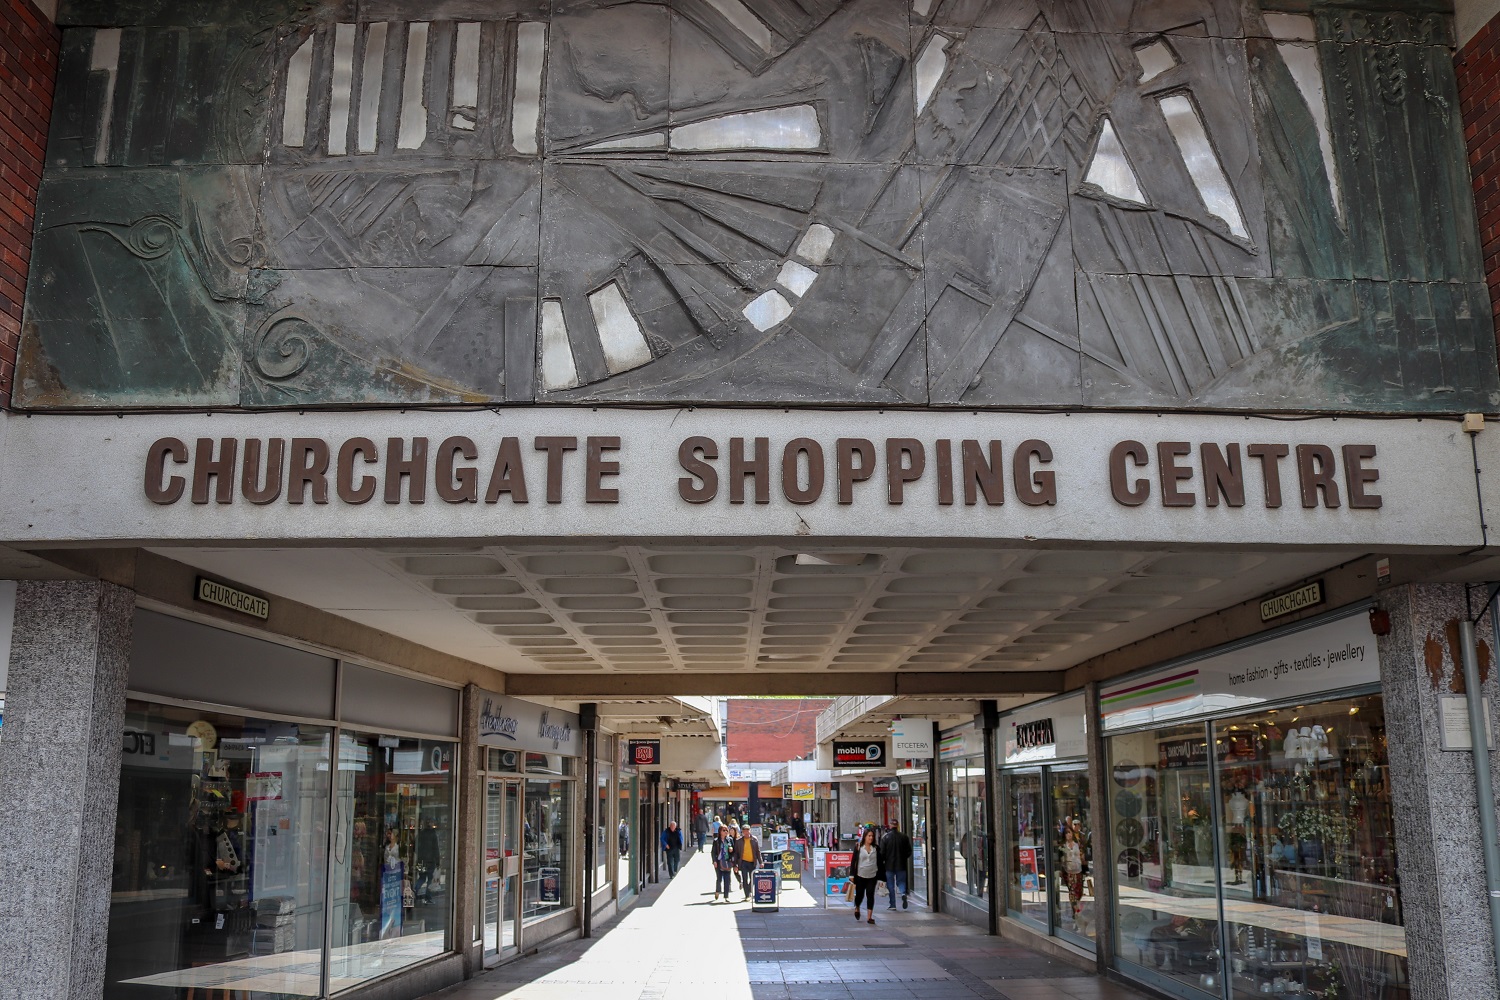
[143,435,1383,510]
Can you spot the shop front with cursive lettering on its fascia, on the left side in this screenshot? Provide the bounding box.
[479,691,582,963]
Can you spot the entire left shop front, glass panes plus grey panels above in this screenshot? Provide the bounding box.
[104,610,459,1000]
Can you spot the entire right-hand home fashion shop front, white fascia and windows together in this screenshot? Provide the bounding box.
[1100,607,1409,1000]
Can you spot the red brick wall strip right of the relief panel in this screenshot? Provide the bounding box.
[1454,16,1500,352]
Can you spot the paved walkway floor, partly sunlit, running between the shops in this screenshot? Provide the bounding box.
[431,856,1145,1000]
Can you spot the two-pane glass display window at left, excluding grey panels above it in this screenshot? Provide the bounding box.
[104,700,453,1000]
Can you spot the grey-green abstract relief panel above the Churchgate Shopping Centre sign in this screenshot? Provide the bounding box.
[15,0,1500,411]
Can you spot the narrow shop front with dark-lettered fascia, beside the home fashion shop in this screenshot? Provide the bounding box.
[996,693,1098,949]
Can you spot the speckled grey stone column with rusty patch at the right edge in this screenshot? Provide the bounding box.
[1376,585,1500,1000]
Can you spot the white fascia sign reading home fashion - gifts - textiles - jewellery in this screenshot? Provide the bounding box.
[1100,612,1380,730]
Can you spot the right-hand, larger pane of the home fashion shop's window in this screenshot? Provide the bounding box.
[1214,696,1407,997]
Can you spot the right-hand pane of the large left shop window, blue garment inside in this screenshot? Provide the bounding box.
[329,732,453,991]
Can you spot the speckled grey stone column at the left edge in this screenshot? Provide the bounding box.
[0,580,135,1000]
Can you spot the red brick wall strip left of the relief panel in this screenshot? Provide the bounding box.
[0,0,59,406]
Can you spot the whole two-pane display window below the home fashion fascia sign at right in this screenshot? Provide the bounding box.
[1109,696,1407,999]
